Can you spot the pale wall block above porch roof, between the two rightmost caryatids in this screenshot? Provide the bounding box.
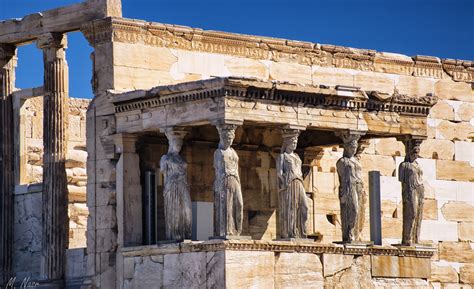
[354,71,398,94]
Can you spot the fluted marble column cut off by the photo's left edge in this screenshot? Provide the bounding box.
[0,44,16,284]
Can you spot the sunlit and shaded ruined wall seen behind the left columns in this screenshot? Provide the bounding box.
[14,97,90,275]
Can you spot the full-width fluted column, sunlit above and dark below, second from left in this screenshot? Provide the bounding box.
[37,33,69,286]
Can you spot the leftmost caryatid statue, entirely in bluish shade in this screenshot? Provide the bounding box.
[160,128,192,240]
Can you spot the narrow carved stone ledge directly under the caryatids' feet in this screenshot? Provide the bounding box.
[122,240,436,259]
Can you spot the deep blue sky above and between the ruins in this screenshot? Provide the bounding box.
[0,0,474,98]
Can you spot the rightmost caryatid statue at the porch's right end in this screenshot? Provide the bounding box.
[398,138,425,246]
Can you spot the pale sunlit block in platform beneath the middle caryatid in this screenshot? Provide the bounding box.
[275,252,324,288]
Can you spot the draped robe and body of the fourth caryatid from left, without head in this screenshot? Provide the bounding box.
[336,156,364,242]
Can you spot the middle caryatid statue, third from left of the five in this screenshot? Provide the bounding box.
[276,129,309,239]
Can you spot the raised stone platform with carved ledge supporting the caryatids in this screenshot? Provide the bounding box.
[121,240,435,288]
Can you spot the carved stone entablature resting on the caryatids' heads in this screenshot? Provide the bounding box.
[112,77,436,137]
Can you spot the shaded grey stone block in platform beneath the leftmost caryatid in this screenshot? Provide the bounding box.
[163,252,207,288]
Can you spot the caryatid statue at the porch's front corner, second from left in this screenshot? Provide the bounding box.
[214,123,243,237]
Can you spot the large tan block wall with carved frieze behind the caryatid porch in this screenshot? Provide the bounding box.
[83,16,474,288]
